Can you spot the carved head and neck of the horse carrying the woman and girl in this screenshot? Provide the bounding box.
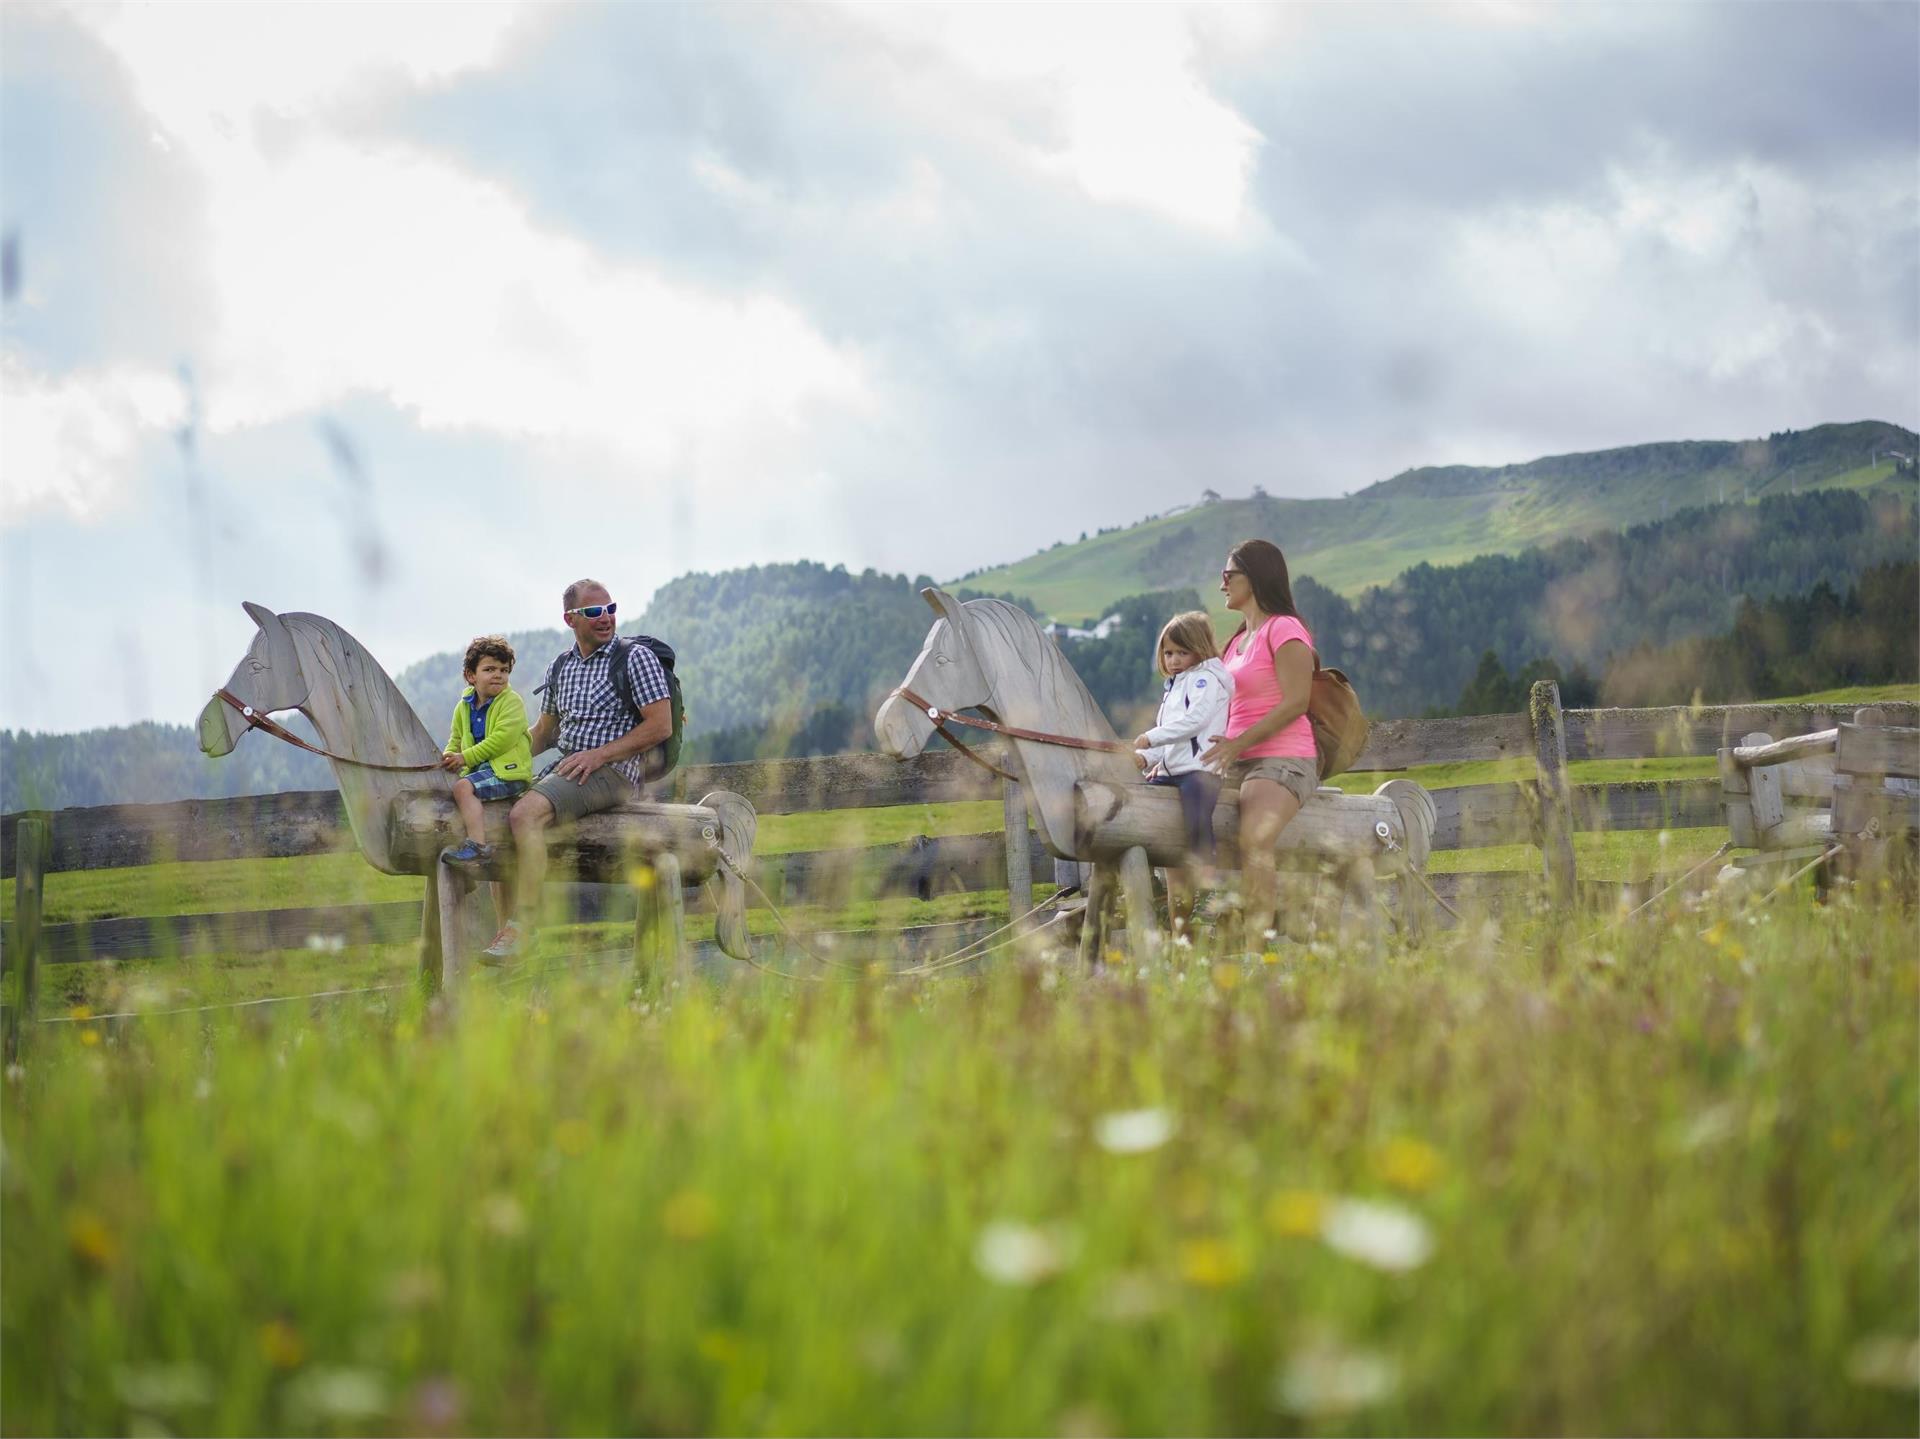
[874,590,1137,859]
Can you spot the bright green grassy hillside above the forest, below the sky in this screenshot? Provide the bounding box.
[966,421,1920,622]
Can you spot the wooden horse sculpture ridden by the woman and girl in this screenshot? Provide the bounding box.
[874,590,1434,957]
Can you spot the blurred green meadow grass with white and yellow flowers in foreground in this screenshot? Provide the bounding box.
[0,899,1920,1433]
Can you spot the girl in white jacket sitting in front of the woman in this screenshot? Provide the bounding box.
[1133,609,1233,934]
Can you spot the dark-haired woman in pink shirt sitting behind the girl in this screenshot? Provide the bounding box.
[1202,540,1319,945]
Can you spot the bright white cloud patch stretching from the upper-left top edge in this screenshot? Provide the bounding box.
[33,6,872,513]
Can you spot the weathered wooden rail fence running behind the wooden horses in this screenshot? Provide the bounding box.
[0,682,1920,1006]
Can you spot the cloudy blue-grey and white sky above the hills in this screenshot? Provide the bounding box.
[0,0,1920,730]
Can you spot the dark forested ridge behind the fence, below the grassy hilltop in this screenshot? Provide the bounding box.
[0,490,1920,811]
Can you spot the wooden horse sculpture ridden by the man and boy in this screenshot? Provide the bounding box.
[200,603,756,978]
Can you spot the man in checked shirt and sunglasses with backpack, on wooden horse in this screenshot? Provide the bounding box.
[482,580,674,963]
